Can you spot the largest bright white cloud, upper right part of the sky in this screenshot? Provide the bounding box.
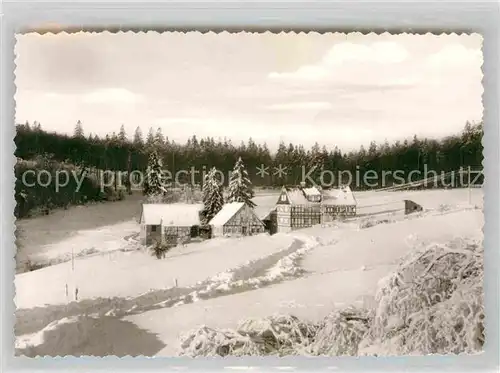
[268,42,409,81]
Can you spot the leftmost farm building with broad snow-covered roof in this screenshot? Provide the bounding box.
[140,203,203,246]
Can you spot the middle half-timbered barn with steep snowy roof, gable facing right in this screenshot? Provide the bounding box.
[209,202,265,237]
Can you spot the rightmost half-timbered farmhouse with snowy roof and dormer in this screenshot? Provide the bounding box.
[274,187,356,232]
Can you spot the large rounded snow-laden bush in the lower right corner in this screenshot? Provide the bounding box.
[360,240,484,355]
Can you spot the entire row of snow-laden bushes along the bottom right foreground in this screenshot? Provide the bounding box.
[177,240,484,356]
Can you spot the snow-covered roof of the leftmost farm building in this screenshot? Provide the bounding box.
[142,203,203,227]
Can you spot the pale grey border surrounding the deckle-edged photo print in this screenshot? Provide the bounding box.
[0,0,500,372]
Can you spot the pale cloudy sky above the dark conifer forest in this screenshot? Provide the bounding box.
[15,32,483,150]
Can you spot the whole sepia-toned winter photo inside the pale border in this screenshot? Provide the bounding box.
[14,31,487,358]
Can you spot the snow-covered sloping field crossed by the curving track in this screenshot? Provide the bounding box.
[15,189,483,356]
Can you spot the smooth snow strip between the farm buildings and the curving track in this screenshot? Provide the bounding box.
[15,231,294,308]
